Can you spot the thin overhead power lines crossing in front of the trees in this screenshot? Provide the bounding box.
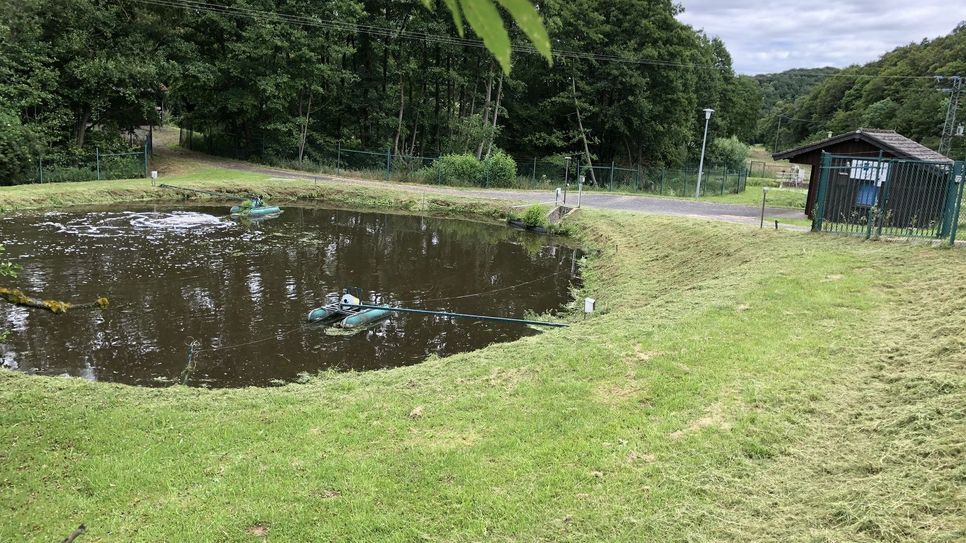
[133,0,960,79]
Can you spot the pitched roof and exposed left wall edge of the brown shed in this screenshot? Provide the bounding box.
[772,128,952,216]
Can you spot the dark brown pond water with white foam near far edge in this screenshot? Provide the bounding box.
[0,206,579,387]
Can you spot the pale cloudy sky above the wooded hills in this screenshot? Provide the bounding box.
[678,0,966,74]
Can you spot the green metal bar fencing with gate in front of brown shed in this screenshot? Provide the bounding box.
[812,153,964,243]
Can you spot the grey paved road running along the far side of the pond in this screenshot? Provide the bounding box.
[185,154,805,230]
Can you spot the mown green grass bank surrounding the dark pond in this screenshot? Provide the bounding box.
[0,172,966,542]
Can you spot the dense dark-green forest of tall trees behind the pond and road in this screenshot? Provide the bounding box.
[0,0,761,185]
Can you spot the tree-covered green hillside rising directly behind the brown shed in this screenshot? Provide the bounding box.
[758,22,966,159]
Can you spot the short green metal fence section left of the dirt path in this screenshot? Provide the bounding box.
[33,143,151,183]
